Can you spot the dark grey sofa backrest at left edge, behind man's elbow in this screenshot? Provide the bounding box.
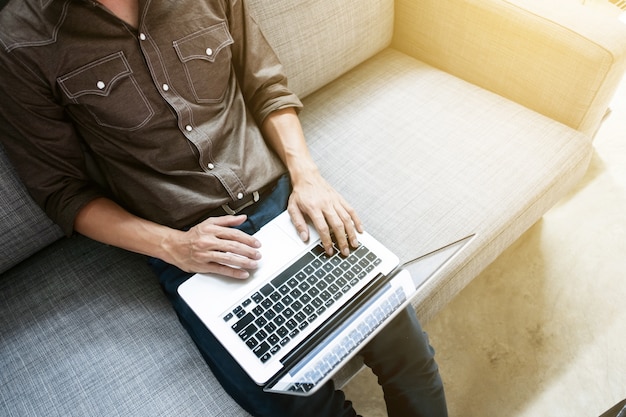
[0,141,63,273]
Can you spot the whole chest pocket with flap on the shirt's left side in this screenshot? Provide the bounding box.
[57,52,154,130]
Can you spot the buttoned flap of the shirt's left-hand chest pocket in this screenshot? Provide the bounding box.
[58,52,132,99]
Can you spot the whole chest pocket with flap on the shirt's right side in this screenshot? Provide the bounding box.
[173,22,233,103]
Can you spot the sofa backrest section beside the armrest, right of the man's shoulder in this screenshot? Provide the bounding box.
[248,0,394,98]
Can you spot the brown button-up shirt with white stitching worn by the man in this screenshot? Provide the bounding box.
[0,0,301,234]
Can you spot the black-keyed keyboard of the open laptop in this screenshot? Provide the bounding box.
[223,245,381,363]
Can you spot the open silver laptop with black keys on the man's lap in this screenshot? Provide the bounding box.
[178,212,473,395]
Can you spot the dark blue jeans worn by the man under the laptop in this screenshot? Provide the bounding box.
[150,177,447,417]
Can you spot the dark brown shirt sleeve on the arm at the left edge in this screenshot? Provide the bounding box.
[0,50,104,235]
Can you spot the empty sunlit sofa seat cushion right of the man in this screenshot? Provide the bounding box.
[301,49,592,321]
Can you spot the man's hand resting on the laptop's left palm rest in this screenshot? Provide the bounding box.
[163,216,261,279]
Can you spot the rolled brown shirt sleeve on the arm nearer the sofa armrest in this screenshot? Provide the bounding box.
[229,0,302,125]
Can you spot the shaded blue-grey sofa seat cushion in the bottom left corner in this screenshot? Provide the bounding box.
[0,236,247,417]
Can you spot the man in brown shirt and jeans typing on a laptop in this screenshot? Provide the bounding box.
[0,0,446,416]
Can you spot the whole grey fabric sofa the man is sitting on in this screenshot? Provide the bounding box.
[0,0,626,417]
